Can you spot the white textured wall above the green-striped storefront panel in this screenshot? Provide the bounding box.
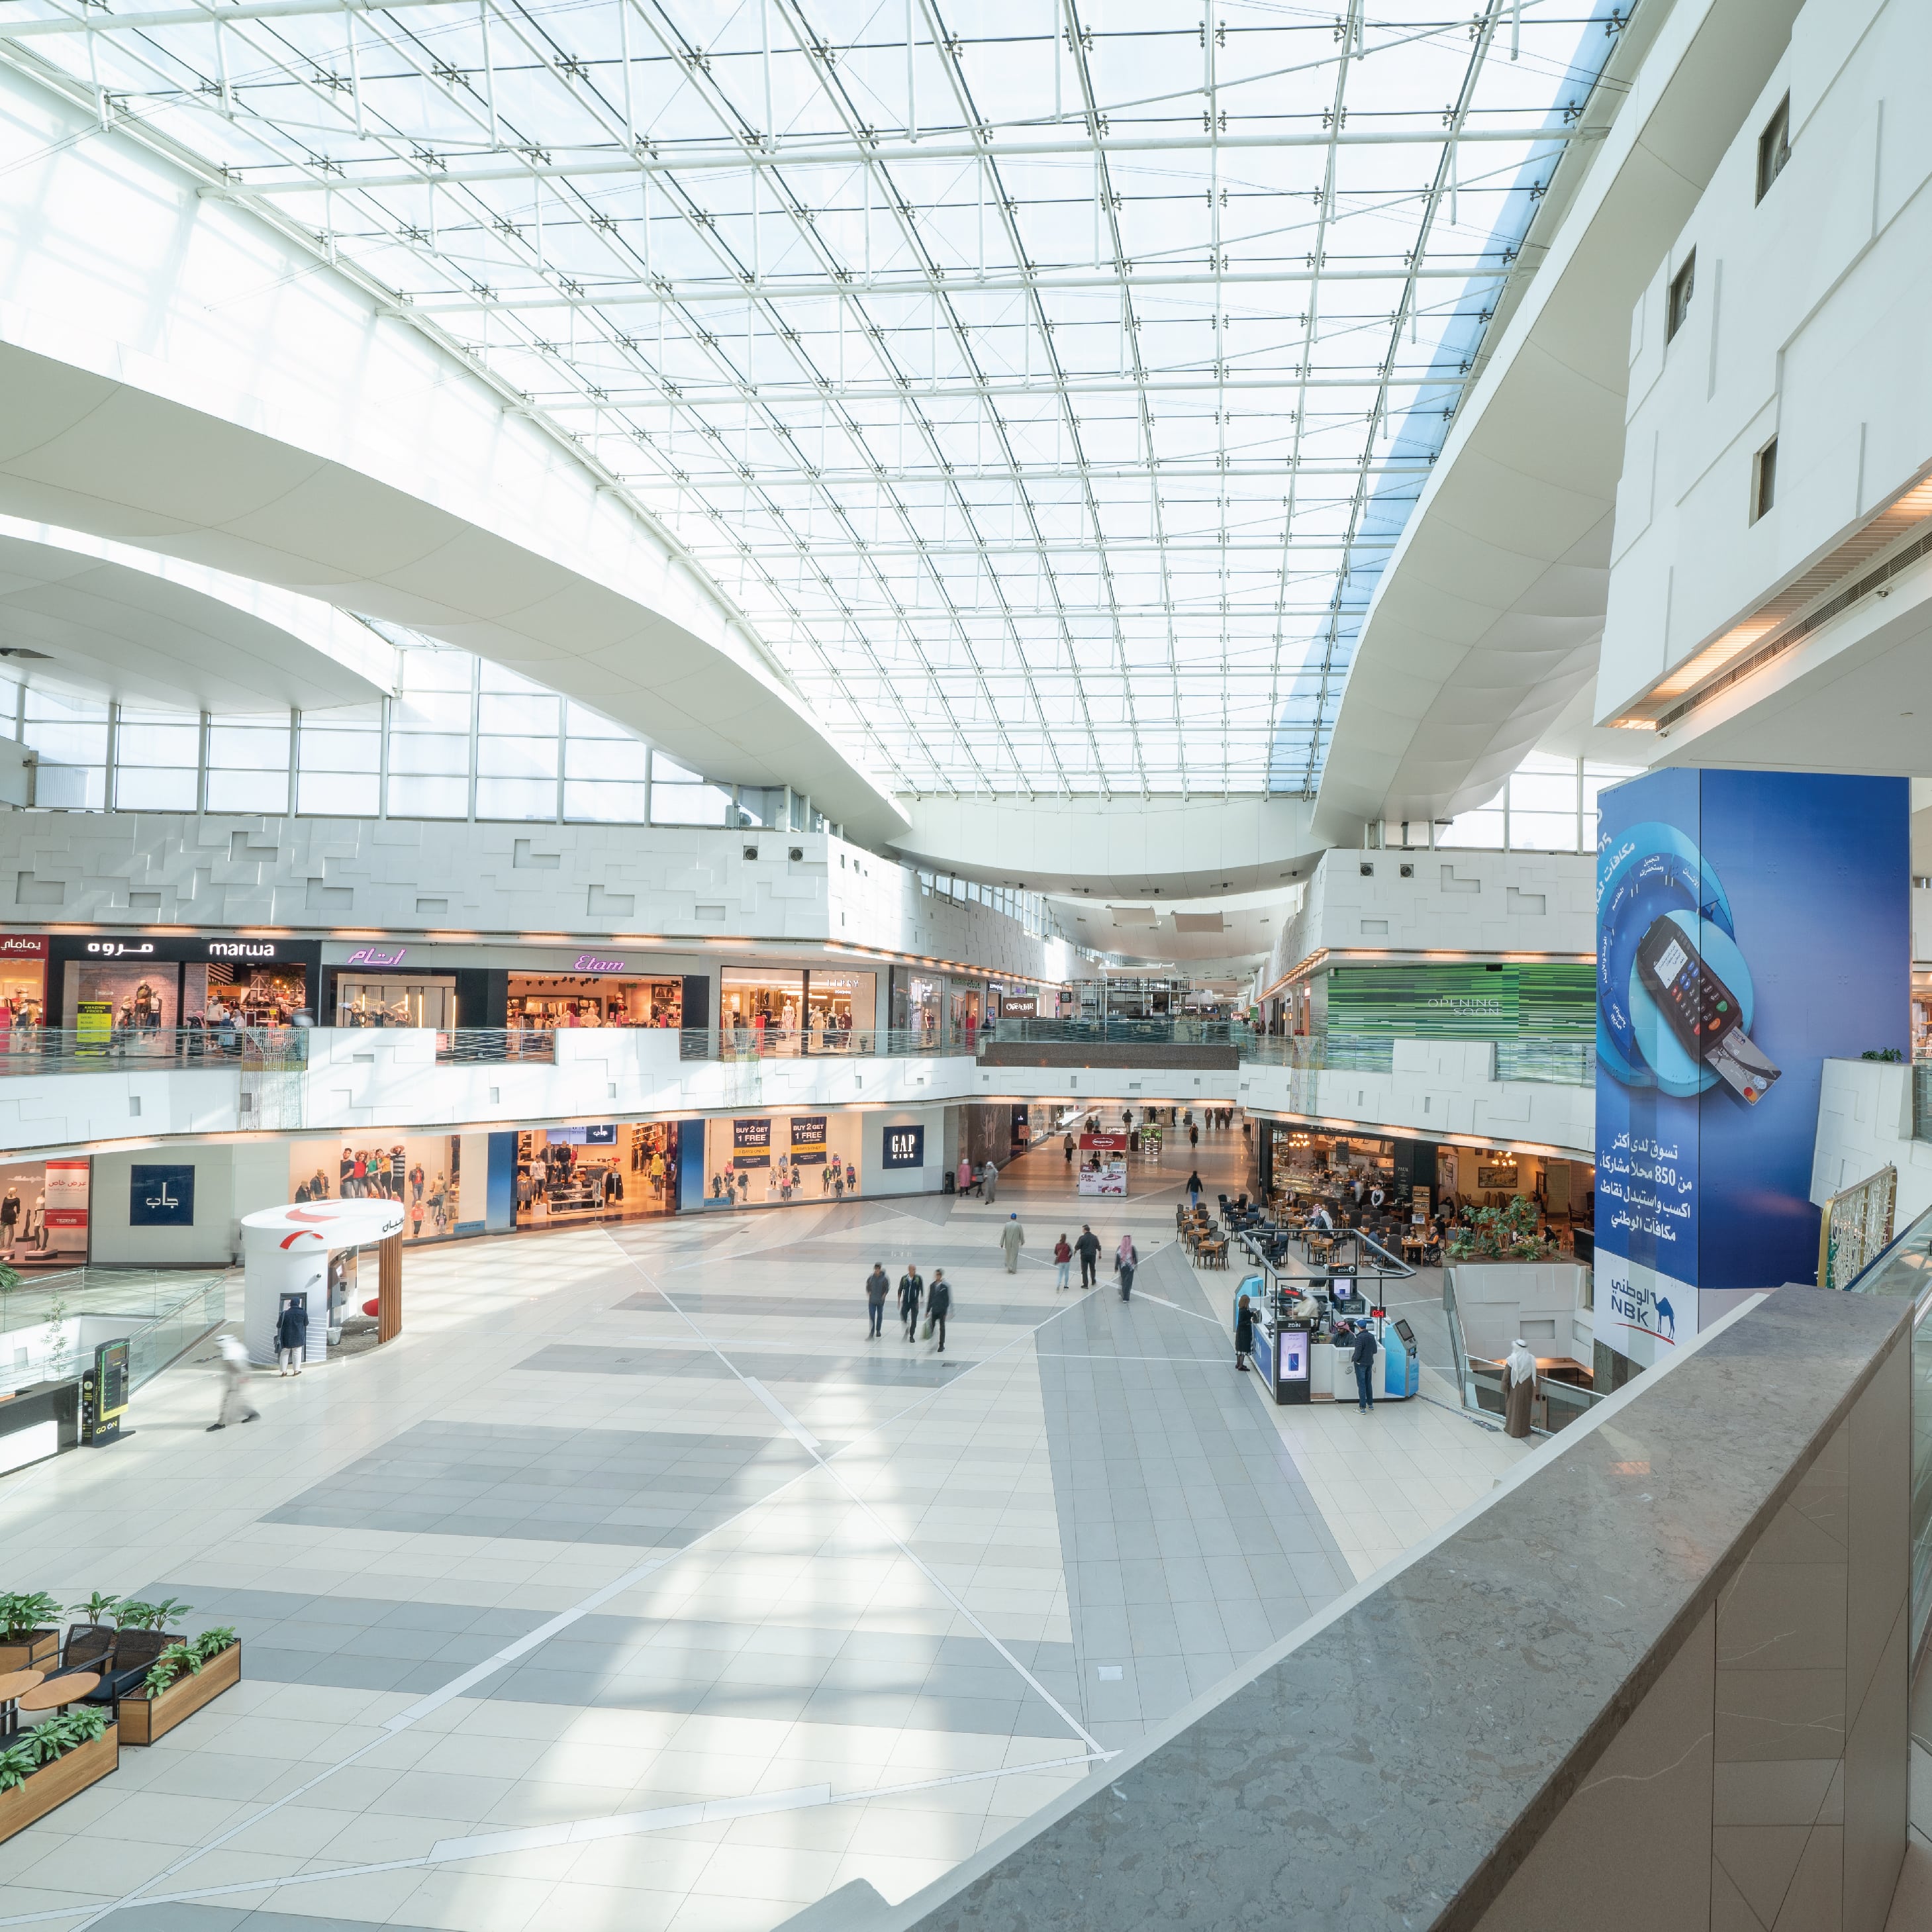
[1261,850,1596,989]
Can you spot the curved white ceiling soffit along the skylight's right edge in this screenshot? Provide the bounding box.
[1316,0,1799,842]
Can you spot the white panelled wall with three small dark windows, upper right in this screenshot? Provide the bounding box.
[1596,0,1932,722]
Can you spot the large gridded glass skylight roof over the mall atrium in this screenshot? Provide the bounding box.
[0,0,1629,796]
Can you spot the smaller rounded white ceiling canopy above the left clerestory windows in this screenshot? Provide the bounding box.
[0,516,396,713]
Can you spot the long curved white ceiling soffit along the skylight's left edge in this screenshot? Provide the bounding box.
[0,73,904,840]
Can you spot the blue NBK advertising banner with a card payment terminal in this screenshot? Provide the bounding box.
[1596,771,1911,1362]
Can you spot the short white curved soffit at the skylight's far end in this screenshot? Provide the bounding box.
[894,794,1318,900]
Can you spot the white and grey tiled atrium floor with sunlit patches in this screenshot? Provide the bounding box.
[0,1134,1522,1932]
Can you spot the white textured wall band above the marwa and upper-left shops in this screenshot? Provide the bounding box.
[0,812,1072,981]
